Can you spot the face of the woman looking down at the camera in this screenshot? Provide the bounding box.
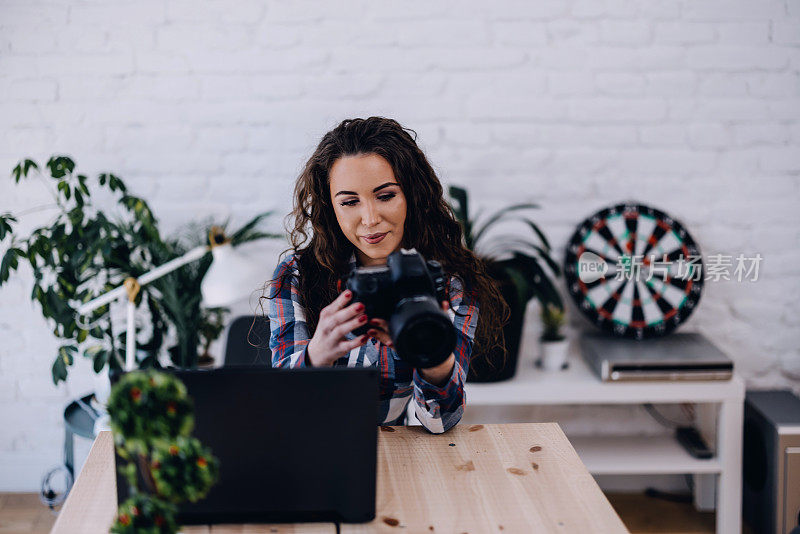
[328,154,406,265]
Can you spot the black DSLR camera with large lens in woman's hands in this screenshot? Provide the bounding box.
[346,249,456,369]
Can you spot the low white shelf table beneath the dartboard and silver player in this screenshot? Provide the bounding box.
[466,341,745,534]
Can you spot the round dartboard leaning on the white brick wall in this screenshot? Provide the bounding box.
[564,203,704,339]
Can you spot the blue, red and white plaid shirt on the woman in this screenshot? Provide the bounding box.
[268,254,478,434]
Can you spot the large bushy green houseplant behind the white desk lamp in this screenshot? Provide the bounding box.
[0,156,276,384]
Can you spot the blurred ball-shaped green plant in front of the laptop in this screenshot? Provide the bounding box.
[108,369,219,534]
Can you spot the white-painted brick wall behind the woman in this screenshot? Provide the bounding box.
[0,0,800,490]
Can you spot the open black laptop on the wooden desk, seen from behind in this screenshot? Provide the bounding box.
[112,367,378,524]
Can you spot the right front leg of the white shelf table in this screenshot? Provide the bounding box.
[717,399,744,534]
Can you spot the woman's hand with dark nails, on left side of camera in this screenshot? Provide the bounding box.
[306,289,369,367]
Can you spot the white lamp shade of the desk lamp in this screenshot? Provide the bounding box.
[200,243,266,308]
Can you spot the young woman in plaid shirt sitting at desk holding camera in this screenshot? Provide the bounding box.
[267,117,507,433]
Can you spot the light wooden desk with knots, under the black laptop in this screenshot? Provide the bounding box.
[53,423,627,534]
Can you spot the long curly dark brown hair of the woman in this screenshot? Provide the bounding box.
[271,117,510,364]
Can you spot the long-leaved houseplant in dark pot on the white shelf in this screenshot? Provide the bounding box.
[449,186,563,382]
